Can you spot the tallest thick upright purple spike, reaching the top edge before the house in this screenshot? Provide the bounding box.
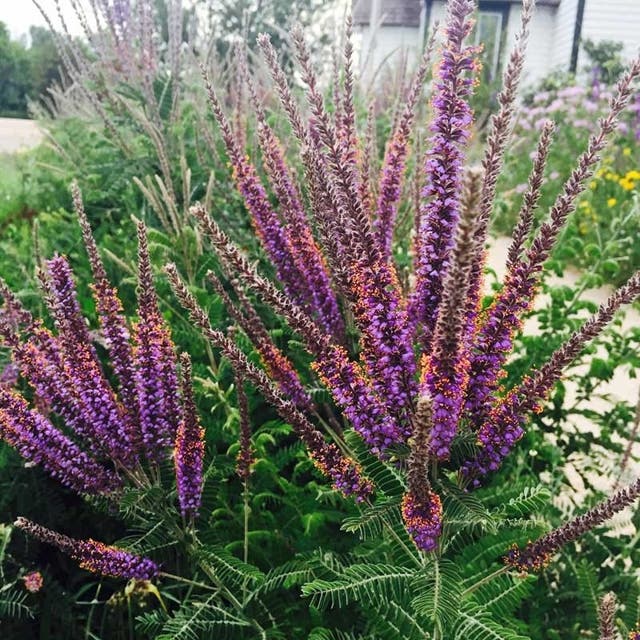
[409,0,477,344]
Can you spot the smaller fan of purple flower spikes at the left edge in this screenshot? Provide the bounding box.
[0,186,204,532]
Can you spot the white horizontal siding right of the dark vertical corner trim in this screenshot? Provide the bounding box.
[578,0,640,68]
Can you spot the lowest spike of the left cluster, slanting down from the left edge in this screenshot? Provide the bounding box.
[0,385,120,495]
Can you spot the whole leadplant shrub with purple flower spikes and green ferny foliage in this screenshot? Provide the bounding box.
[0,0,640,640]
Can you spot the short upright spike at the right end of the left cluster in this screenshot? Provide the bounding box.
[174,354,204,518]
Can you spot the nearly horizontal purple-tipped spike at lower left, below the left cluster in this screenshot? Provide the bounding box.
[15,518,160,580]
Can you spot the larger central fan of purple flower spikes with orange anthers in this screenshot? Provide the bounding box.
[168,0,640,552]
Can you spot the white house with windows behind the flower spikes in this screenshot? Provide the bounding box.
[353,0,640,83]
